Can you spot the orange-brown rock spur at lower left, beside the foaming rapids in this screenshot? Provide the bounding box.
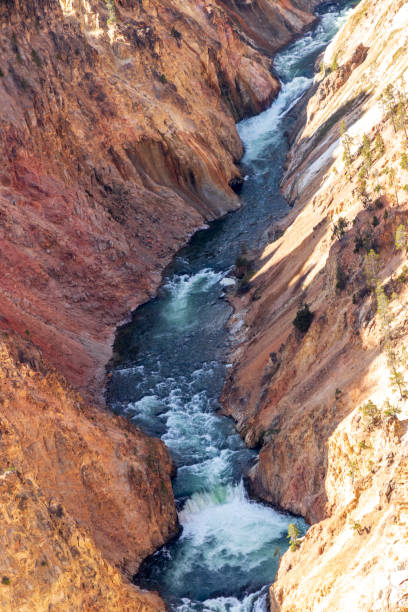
[0,334,178,610]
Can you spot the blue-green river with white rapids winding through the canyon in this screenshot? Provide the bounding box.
[108,1,357,612]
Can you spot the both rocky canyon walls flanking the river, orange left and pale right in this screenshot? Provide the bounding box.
[0,0,408,612]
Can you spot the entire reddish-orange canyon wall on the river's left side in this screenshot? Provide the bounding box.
[0,0,316,612]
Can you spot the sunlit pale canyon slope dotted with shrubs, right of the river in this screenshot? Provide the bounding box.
[224,0,408,612]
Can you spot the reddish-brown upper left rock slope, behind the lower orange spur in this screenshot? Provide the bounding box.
[0,0,313,396]
